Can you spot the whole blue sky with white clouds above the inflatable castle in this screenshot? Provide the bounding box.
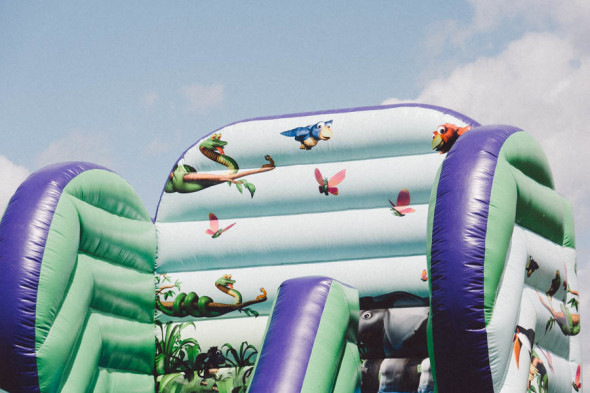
[0,0,590,380]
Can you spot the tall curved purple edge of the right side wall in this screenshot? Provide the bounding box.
[430,126,518,393]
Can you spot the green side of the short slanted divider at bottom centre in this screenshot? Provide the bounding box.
[301,281,360,393]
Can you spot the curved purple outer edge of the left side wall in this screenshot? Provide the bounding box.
[0,162,104,392]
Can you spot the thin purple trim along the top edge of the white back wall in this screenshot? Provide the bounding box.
[154,103,479,217]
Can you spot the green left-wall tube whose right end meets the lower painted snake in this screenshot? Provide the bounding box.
[78,254,154,326]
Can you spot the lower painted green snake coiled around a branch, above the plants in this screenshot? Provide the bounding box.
[156,274,267,318]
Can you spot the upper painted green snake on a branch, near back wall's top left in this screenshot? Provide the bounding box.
[164,134,275,198]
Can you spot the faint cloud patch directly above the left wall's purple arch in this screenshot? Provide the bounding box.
[36,131,115,168]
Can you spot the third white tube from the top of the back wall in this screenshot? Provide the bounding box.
[156,205,428,273]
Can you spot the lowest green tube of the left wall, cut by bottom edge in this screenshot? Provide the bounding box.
[94,369,155,393]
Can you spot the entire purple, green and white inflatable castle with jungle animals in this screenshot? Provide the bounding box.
[0,104,582,393]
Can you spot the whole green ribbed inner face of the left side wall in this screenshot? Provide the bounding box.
[36,170,156,392]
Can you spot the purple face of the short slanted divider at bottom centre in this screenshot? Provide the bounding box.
[249,277,332,393]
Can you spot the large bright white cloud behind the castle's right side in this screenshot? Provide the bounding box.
[417,33,590,227]
